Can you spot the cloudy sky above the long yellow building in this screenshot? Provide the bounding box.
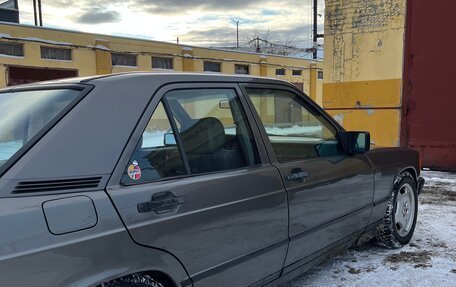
[19,0,324,48]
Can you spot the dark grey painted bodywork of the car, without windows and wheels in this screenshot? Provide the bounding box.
[0,73,419,286]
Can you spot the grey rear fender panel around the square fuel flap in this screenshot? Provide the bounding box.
[0,190,188,287]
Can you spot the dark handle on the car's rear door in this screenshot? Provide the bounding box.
[138,191,185,214]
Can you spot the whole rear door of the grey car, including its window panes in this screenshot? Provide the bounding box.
[107,83,288,286]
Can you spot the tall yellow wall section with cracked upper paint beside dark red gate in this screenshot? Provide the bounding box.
[323,0,406,146]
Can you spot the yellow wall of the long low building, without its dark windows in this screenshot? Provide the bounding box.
[0,23,323,105]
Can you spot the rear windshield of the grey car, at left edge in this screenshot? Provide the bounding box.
[0,89,81,168]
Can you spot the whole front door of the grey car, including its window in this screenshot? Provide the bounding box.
[243,85,373,273]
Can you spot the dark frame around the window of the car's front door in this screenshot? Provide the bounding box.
[239,83,343,165]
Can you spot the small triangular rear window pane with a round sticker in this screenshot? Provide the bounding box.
[121,102,186,185]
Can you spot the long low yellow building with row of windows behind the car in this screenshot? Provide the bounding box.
[0,23,323,104]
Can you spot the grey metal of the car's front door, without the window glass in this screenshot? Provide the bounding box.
[242,84,374,267]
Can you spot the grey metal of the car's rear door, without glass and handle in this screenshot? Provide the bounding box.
[104,83,288,286]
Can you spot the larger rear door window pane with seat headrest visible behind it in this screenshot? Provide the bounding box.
[165,89,259,174]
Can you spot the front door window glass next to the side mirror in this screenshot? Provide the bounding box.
[246,88,344,162]
